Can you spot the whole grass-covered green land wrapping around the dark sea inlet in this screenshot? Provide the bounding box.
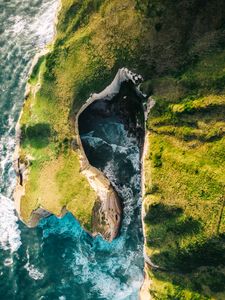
[16,0,225,299]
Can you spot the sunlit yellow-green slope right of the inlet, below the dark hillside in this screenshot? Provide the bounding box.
[145,41,225,299]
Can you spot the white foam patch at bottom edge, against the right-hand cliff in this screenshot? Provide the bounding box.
[72,248,143,300]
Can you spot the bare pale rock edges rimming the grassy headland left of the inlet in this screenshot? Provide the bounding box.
[14,65,147,241]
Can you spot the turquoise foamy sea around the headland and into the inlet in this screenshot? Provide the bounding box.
[0,0,143,300]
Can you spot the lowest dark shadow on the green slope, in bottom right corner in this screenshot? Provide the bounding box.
[152,234,225,299]
